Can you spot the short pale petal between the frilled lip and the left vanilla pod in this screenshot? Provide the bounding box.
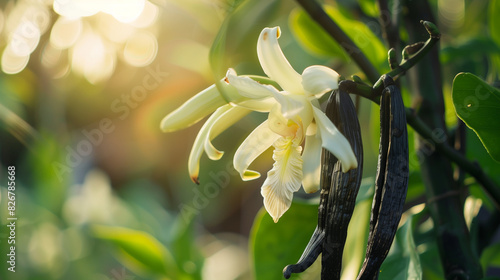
[302,135,322,193]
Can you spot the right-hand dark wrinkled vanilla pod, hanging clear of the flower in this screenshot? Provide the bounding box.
[357,77,409,280]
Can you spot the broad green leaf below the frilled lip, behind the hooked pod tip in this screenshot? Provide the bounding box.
[250,201,318,280]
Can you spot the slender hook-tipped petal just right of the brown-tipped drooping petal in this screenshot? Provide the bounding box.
[204,107,251,160]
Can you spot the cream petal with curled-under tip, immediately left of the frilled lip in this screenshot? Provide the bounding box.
[233,120,280,181]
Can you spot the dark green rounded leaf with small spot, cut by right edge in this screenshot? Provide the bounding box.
[452,73,500,161]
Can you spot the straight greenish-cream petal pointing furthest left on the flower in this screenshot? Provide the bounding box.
[160,85,227,132]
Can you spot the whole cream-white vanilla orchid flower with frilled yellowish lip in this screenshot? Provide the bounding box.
[161,27,357,222]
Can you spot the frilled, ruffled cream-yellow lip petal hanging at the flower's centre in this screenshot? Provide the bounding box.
[260,137,302,223]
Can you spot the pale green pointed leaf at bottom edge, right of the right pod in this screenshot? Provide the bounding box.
[379,216,422,280]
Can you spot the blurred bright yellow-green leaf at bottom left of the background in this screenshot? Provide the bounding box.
[92,225,177,279]
